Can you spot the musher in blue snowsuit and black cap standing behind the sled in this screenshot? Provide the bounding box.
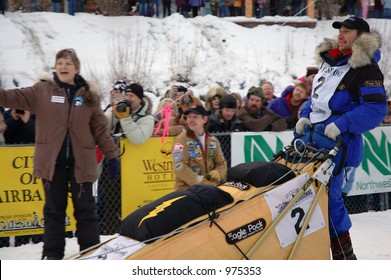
[295,17,387,259]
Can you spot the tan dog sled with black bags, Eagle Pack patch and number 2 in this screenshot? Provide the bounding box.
[73,139,340,260]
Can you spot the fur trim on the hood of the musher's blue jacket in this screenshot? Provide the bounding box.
[316,31,382,69]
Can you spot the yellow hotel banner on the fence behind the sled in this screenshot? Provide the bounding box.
[121,137,175,218]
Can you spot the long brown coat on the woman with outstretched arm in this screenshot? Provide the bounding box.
[0,78,117,183]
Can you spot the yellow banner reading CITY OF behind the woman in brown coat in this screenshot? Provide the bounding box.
[0,146,76,237]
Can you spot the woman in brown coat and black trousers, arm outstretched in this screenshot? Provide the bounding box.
[0,49,119,259]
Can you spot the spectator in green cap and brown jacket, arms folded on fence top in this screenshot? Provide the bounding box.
[238,86,287,131]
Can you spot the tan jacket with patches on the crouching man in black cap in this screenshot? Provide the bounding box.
[172,131,227,190]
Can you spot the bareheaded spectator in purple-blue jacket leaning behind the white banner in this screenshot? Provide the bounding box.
[267,82,309,129]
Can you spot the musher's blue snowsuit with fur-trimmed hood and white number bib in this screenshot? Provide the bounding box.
[300,32,387,237]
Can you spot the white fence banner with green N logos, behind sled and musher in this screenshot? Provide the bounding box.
[231,126,391,195]
